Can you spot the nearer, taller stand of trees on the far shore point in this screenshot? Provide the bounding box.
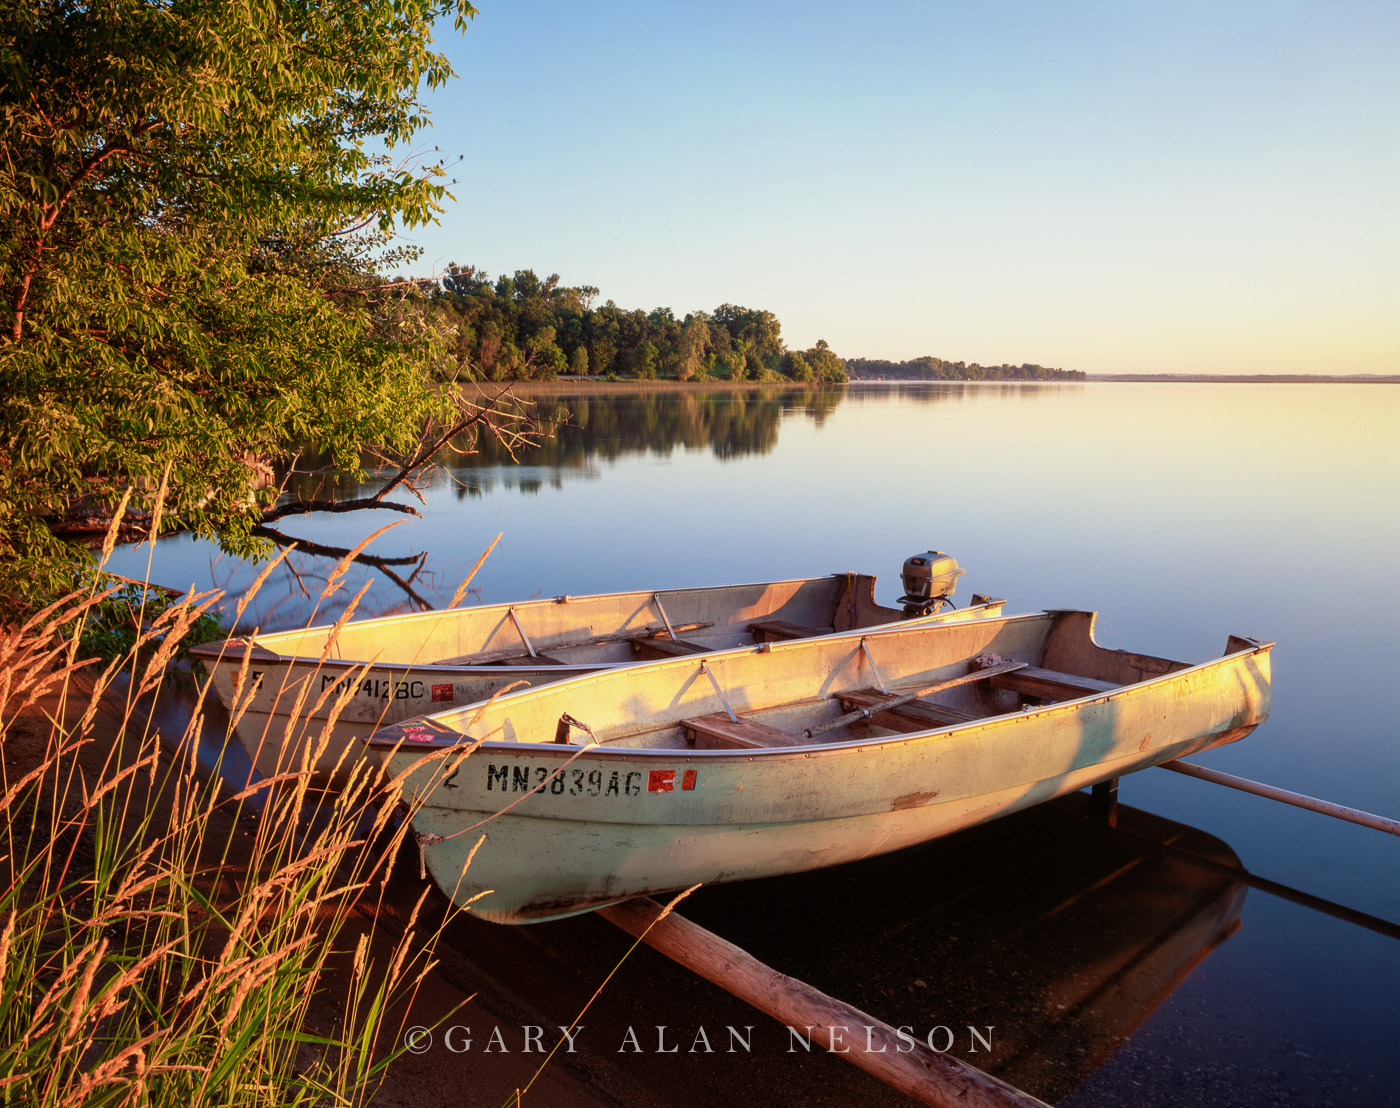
[427,266,847,384]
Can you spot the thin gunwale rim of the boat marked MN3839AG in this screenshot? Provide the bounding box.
[361,627,1275,769]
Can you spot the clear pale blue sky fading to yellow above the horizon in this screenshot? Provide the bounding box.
[400,0,1400,373]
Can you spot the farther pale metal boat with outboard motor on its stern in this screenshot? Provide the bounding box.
[190,550,1002,786]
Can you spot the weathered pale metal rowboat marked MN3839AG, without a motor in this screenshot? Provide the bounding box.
[368,611,1273,923]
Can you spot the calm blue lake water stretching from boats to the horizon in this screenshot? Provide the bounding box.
[112,382,1400,1105]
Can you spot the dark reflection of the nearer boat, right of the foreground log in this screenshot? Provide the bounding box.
[682,793,1246,1102]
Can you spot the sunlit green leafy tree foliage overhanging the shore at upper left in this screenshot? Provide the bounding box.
[0,0,475,607]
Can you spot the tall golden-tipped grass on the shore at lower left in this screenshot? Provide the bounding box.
[0,549,453,1108]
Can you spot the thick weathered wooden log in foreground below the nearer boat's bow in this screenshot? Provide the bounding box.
[598,898,1046,1108]
